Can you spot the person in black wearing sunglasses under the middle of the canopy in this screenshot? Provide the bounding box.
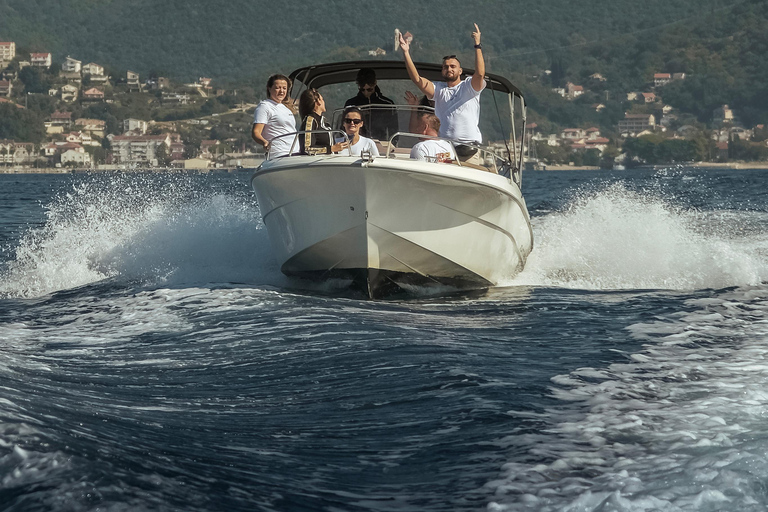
[344,68,398,140]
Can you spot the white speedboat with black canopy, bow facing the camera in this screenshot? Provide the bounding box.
[251,61,533,298]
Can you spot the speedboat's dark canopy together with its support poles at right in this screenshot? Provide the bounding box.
[289,60,527,182]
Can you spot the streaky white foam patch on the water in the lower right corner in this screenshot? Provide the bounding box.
[488,286,768,512]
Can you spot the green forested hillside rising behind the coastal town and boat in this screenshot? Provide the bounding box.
[0,0,768,131]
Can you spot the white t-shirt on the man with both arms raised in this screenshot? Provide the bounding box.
[434,76,485,142]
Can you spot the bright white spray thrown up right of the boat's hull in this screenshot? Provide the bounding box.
[504,184,768,290]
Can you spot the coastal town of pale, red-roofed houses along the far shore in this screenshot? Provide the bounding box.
[0,42,768,172]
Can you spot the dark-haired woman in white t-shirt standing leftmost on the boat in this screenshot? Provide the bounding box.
[251,75,296,158]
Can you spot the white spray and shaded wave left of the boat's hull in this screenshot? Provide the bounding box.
[0,174,284,298]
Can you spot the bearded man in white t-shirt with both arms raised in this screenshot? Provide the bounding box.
[400,23,485,164]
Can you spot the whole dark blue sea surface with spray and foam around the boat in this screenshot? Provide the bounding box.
[0,167,768,512]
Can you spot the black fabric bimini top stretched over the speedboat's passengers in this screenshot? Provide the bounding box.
[290,60,523,98]
